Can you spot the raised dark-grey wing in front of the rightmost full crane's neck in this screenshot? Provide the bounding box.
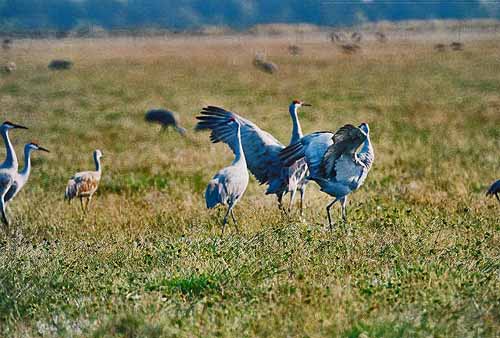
[321,124,366,177]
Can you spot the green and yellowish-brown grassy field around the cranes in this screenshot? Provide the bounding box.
[0,38,500,337]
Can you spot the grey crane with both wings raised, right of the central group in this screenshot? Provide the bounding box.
[280,123,375,230]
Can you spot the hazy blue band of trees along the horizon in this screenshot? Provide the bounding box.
[0,0,500,33]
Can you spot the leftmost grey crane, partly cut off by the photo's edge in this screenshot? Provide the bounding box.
[0,121,28,232]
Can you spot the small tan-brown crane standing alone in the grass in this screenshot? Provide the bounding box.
[64,149,103,212]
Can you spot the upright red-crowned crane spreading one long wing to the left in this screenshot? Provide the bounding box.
[195,100,310,212]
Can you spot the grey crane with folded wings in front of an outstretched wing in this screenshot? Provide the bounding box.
[205,118,248,234]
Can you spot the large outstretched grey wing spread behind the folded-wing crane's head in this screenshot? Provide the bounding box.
[195,106,284,187]
